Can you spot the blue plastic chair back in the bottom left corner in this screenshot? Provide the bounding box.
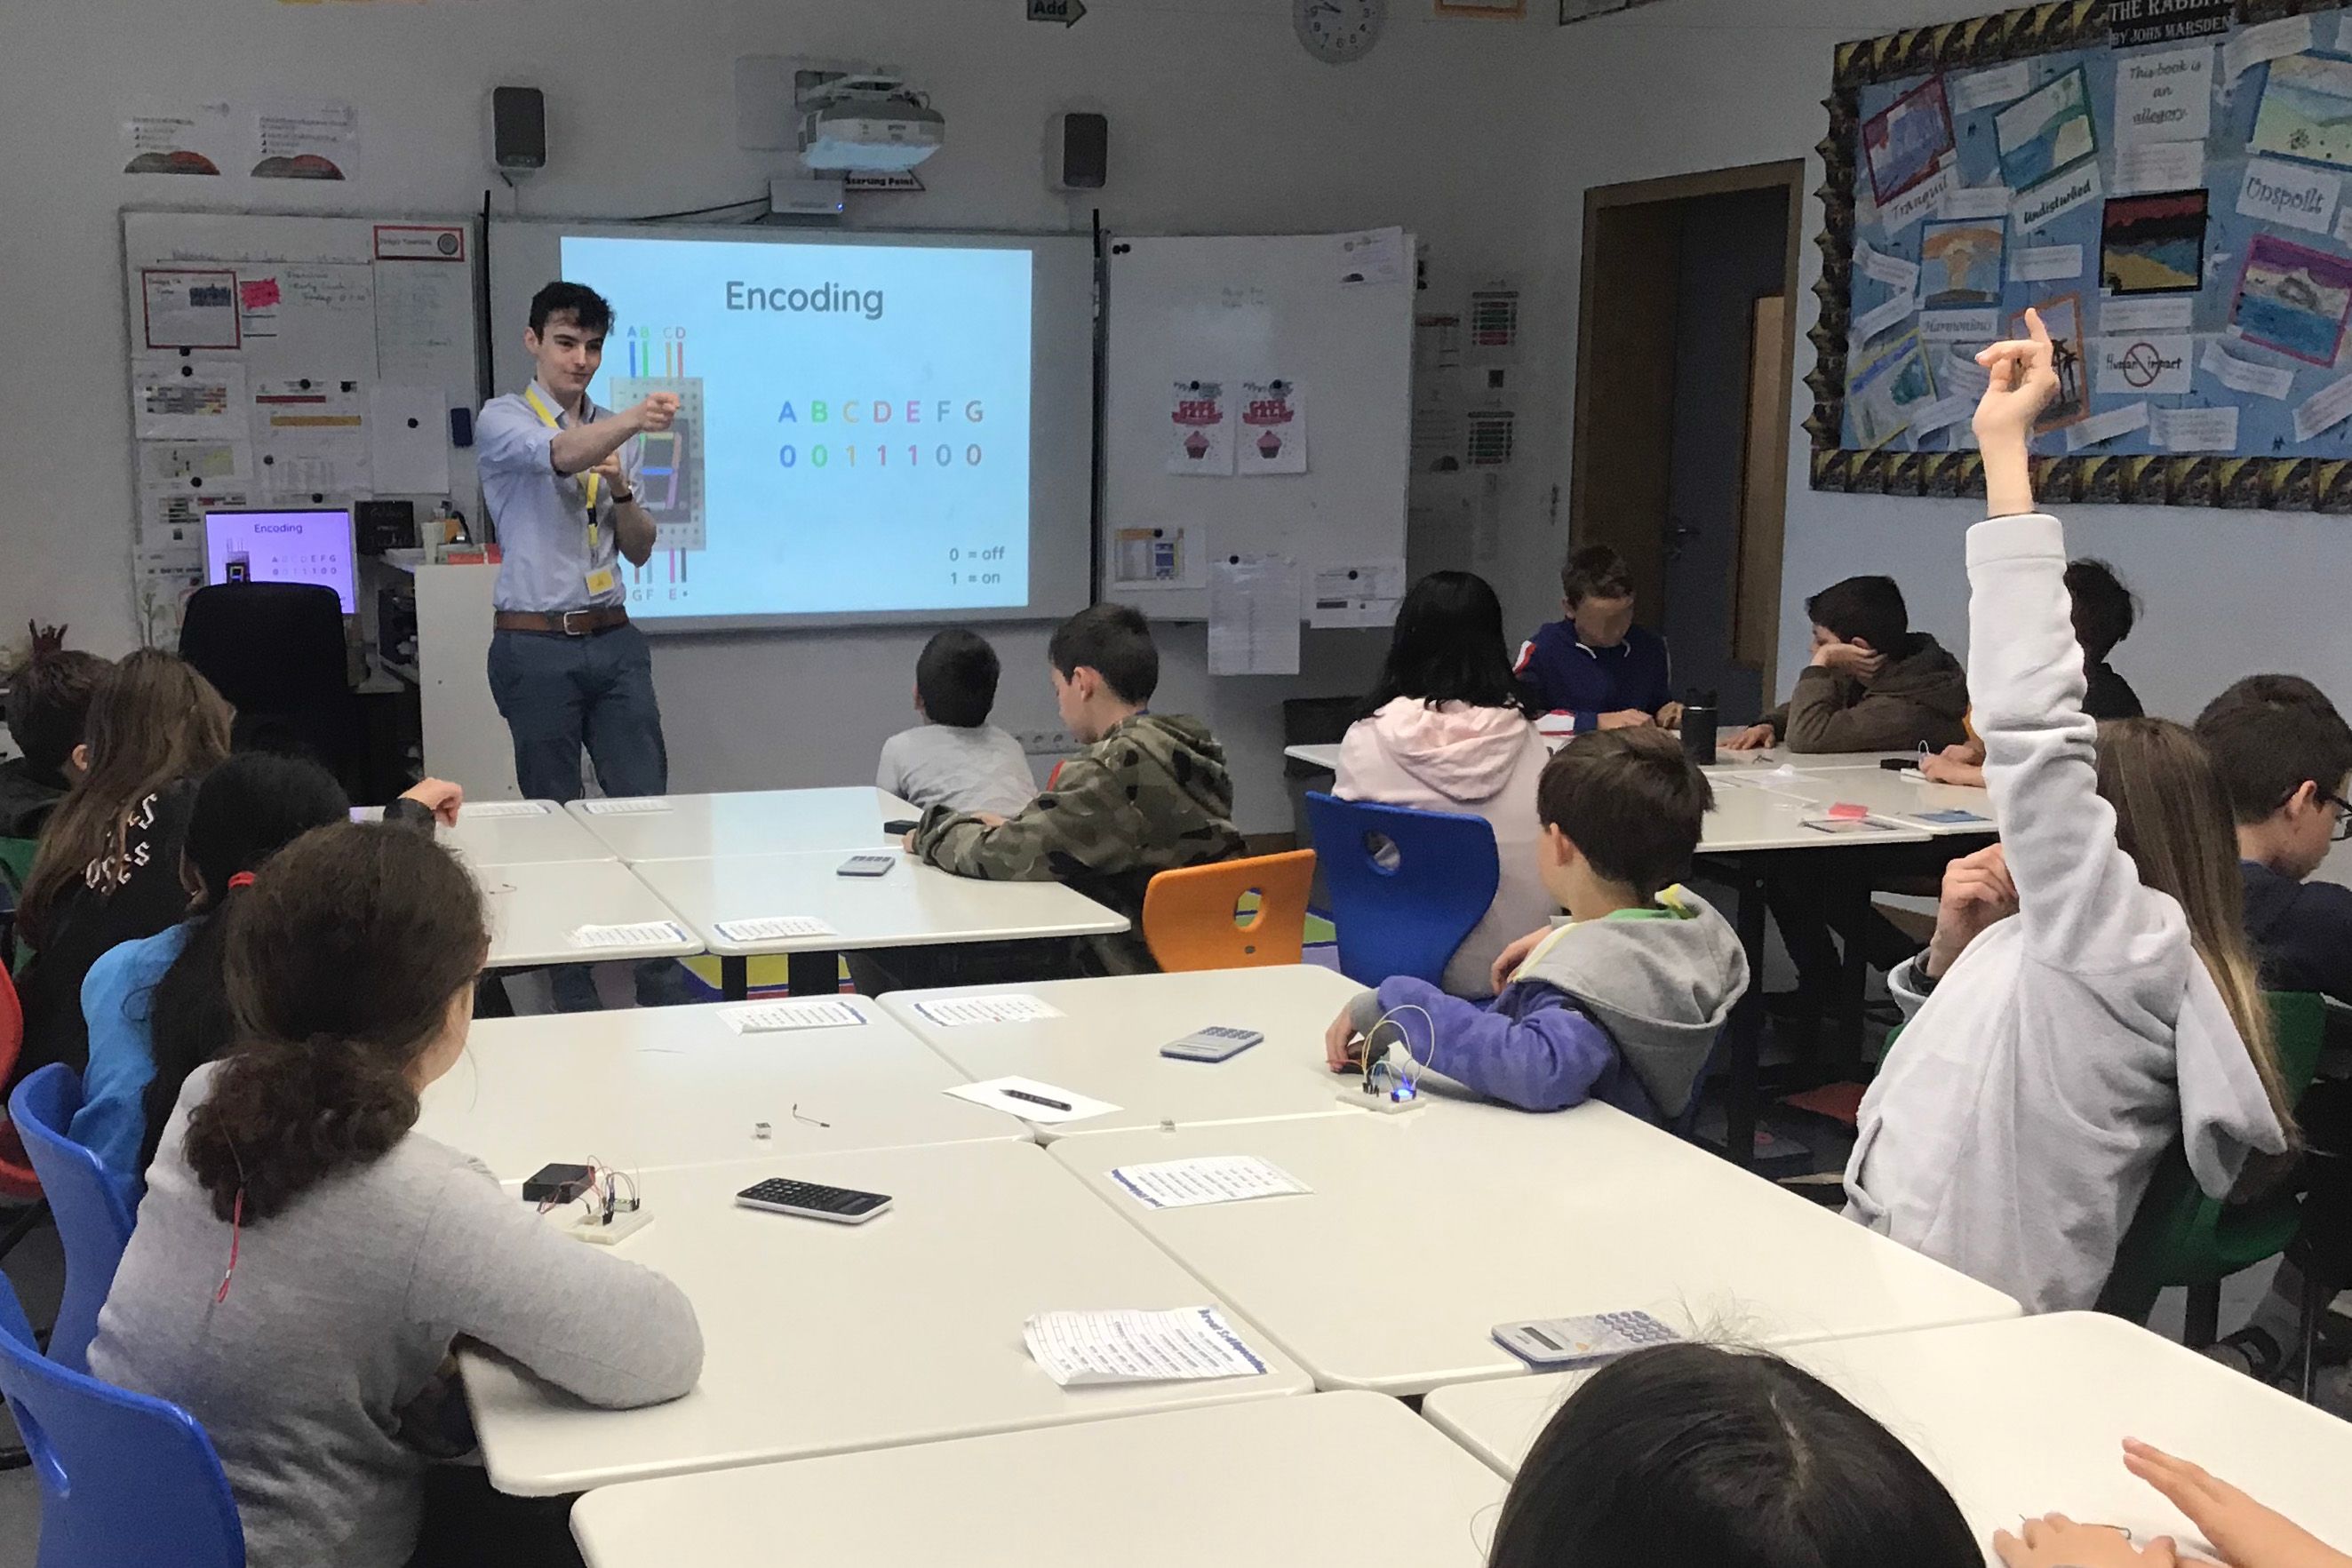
[0,1279,244,1568]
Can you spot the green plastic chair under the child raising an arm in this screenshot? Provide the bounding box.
[2098,992,2326,1349]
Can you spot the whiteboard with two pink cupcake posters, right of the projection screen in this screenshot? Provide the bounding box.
[1101,235,1414,621]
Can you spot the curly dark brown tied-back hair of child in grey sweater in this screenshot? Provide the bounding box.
[183,823,490,1225]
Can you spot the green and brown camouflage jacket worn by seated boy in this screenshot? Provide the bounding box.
[915,712,1242,974]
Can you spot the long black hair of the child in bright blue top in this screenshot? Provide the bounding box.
[139,752,350,1171]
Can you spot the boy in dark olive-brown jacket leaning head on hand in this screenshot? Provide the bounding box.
[1724,576,1969,752]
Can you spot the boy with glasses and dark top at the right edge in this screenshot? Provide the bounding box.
[2197,674,2352,1415]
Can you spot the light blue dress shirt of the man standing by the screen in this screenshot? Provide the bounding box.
[473,381,644,614]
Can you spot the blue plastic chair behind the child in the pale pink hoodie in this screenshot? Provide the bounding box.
[1308,792,1503,985]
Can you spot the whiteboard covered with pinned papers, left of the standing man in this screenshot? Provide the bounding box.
[123,211,480,647]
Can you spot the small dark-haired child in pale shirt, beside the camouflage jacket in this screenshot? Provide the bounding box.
[875,625,1037,816]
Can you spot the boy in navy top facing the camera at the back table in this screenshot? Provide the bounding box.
[1517,545,1682,736]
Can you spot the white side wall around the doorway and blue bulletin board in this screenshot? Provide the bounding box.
[1512,0,2352,720]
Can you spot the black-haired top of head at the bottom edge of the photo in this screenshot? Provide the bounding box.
[1487,1345,1985,1568]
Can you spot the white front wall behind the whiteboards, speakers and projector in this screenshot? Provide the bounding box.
[0,0,1545,830]
